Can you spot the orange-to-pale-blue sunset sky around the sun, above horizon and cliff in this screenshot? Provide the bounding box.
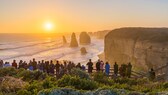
[0,0,168,33]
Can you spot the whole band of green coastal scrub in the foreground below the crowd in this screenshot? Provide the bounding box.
[0,68,168,95]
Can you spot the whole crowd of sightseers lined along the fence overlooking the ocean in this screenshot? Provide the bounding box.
[0,58,155,79]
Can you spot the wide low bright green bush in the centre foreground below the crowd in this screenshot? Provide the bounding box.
[57,75,98,90]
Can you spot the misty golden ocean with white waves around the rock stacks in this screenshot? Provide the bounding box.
[0,34,104,64]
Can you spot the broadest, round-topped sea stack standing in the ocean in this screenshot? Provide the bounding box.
[79,32,91,44]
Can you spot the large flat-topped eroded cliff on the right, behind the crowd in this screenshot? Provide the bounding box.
[104,28,168,70]
